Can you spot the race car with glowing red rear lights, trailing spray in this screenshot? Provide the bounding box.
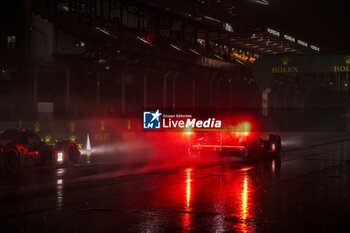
[188,122,281,159]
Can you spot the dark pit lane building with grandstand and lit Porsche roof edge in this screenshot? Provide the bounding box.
[0,0,323,119]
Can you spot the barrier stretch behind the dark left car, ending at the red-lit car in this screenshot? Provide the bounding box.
[0,119,142,148]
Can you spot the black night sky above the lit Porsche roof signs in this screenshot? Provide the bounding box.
[243,0,350,53]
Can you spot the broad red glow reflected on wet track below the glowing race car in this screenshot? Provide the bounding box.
[123,163,272,233]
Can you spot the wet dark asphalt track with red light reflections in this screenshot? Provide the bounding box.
[0,137,350,232]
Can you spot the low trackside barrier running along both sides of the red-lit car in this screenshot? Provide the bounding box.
[0,119,350,150]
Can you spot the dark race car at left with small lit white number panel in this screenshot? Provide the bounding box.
[0,129,80,173]
